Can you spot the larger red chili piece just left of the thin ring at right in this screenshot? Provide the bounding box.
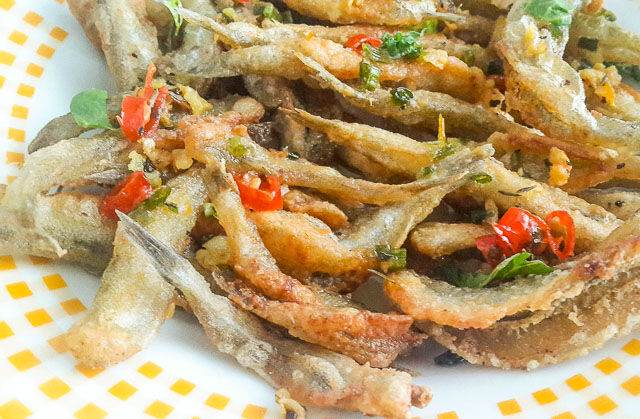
[491,207,548,256]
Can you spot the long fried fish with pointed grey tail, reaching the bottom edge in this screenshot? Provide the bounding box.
[121,215,431,419]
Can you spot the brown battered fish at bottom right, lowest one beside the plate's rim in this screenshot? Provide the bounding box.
[420,267,640,370]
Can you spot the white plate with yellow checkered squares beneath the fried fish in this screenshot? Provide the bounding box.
[0,0,640,419]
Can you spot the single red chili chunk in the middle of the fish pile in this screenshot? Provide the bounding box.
[233,173,282,211]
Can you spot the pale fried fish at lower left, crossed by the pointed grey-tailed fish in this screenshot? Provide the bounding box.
[65,169,206,368]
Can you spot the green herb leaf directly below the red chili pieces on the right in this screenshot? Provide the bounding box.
[441,252,553,288]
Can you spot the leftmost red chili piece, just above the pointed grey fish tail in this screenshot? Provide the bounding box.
[98,171,153,219]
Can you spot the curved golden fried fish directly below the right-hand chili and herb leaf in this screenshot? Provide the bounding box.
[384,237,640,328]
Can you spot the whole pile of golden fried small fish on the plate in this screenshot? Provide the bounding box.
[0,0,640,419]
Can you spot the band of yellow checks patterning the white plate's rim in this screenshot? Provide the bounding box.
[0,0,640,419]
